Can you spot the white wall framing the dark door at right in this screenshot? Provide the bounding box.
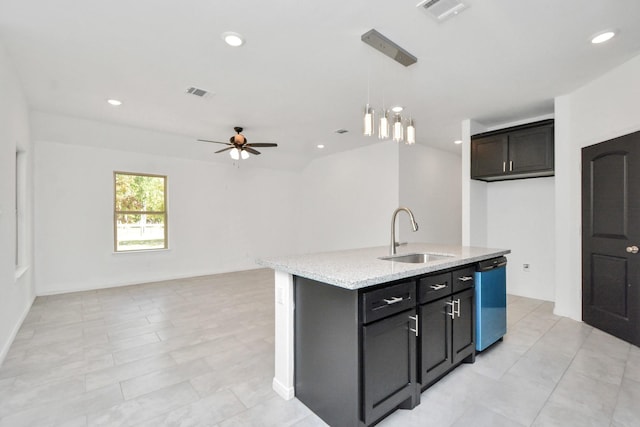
[555,56,640,319]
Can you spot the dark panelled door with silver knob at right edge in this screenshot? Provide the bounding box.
[582,132,640,345]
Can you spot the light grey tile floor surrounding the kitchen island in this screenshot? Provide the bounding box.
[0,270,640,427]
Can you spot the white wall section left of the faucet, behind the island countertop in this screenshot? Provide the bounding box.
[295,142,399,253]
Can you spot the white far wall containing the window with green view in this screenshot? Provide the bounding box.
[33,113,298,295]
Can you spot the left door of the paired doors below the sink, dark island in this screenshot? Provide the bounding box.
[419,298,453,387]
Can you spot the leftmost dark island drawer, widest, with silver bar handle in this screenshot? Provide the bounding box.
[362,281,416,323]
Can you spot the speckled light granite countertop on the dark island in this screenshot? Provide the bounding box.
[256,243,511,290]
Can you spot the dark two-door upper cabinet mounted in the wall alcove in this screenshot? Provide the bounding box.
[471,120,554,181]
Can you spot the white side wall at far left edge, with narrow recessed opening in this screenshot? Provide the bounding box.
[0,45,34,363]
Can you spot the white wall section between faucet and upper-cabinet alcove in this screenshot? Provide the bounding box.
[400,145,462,245]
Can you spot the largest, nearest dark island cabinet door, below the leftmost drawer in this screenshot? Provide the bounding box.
[362,310,417,425]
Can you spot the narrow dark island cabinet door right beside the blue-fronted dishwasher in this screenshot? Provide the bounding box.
[451,289,475,364]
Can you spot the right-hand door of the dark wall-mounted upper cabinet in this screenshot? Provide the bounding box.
[507,126,553,173]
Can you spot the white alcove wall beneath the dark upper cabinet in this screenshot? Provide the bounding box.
[487,177,555,301]
